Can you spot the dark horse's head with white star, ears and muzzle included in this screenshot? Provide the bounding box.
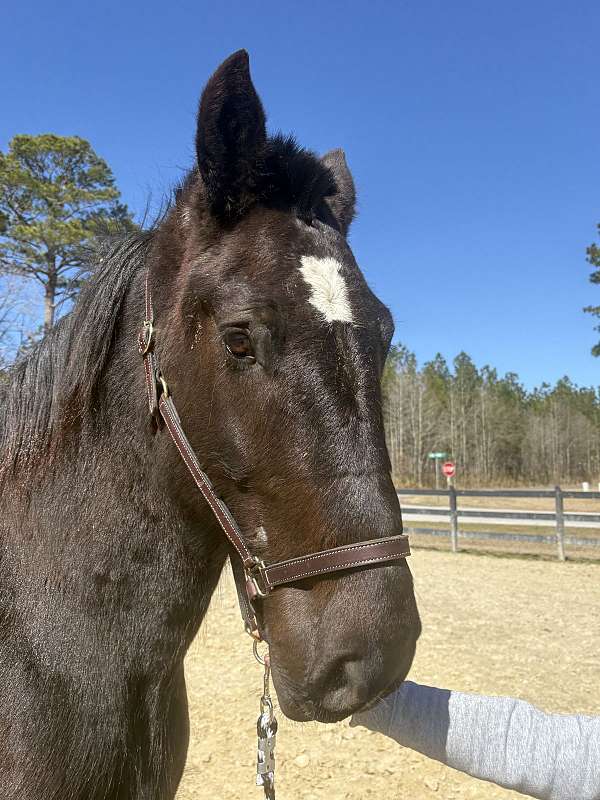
[150,51,420,721]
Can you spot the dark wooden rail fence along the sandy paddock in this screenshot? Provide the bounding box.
[398,486,600,561]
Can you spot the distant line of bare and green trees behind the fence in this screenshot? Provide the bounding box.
[383,345,600,486]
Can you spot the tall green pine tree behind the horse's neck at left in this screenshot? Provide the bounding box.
[0,134,134,332]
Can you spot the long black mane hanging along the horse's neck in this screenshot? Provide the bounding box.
[0,233,151,476]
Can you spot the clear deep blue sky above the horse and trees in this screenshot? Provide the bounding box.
[0,0,600,386]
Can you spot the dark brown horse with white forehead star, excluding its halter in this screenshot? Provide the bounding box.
[0,51,420,800]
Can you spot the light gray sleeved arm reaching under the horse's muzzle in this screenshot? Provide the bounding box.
[351,681,600,800]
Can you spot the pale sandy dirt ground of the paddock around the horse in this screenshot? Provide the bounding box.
[177,550,600,800]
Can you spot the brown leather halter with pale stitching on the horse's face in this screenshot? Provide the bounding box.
[138,271,410,639]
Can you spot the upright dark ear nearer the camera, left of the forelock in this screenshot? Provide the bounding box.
[196,50,267,218]
